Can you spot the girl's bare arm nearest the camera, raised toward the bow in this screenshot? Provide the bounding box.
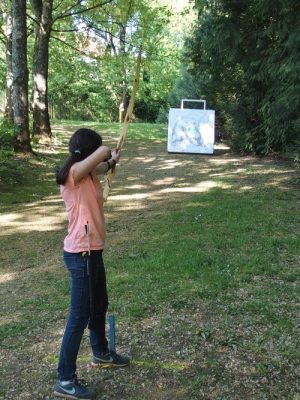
[73,146,111,185]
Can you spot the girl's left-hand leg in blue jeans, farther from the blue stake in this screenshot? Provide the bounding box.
[58,252,90,381]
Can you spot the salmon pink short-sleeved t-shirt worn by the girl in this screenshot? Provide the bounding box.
[60,167,105,253]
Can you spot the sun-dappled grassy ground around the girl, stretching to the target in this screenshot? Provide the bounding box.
[0,122,300,400]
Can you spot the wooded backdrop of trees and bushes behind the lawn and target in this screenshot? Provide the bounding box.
[0,0,300,161]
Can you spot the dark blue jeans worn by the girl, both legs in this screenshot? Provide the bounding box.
[58,250,108,380]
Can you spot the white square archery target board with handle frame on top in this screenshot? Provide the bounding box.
[168,99,215,154]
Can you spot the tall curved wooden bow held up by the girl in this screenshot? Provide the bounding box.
[103,50,142,201]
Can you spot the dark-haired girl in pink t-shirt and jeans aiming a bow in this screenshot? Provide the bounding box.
[54,128,129,399]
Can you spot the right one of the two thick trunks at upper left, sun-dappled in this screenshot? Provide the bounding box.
[31,0,53,140]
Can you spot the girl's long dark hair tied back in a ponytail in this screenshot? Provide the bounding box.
[55,128,102,185]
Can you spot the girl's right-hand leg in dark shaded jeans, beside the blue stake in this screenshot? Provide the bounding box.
[90,251,108,357]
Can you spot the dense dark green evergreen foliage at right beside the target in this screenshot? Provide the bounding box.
[185,0,300,158]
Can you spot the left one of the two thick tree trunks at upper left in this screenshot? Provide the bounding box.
[11,0,32,152]
